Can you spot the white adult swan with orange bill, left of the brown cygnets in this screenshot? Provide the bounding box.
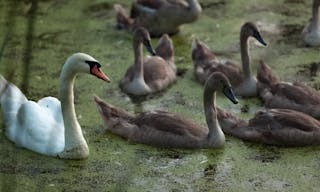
[0,53,110,159]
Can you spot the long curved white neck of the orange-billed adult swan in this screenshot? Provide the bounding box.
[60,64,88,154]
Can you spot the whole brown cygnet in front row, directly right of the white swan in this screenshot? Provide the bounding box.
[95,72,238,148]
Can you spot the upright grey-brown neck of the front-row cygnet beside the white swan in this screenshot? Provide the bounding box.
[203,85,225,147]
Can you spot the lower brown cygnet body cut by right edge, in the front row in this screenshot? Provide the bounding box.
[218,106,320,147]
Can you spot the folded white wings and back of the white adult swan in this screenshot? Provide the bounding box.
[13,97,65,155]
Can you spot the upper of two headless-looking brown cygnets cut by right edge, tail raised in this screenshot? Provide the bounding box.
[257,62,320,119]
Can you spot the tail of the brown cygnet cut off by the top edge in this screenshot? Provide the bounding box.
[113,4,133,29]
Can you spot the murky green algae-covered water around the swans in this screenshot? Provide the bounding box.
[0,0,320,192]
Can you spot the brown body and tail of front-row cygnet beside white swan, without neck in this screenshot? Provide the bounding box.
[95,97,208,148]
